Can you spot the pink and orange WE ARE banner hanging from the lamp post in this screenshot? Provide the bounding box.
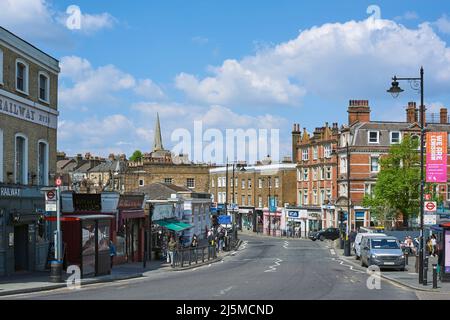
[426,132,447,183]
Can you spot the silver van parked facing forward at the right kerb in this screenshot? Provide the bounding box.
[361,236,405,271]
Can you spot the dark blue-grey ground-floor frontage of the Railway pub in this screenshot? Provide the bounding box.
[0,185,51,276]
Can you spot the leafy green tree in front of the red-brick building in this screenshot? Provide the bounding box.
[363,135,420,226]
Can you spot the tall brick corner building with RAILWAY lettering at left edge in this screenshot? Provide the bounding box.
[0,27,60,275]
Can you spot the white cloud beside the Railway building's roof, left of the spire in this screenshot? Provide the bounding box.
[59,56,164,108]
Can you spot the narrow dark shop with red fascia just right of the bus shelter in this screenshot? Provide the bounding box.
[113,193,148,264]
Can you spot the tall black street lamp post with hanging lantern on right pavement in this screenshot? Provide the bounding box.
[387,67,426,285]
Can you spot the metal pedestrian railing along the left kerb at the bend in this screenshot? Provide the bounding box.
[172,246,217,268]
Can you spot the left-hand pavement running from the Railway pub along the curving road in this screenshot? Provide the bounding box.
[0,241,242,297]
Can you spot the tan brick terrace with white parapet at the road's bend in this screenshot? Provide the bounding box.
[210,160,296,235]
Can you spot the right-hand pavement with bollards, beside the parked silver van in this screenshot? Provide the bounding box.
[333,241,450,293]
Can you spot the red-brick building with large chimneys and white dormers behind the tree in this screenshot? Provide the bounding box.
[334,100,450,229]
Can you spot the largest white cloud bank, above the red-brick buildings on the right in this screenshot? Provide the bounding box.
[175,19,450,106]
